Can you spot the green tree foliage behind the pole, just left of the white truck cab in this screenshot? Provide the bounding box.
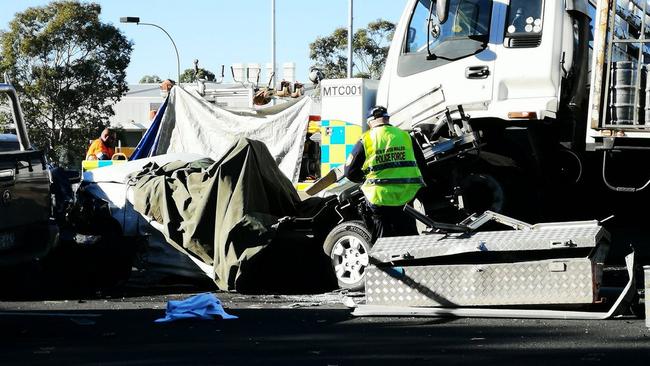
[309,19,395,79]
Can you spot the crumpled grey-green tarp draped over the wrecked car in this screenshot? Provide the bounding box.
[126,139,327,291]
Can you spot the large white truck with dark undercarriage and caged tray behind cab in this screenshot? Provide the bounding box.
[340,0,650,219]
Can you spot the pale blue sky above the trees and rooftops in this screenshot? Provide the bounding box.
[0,0,406,83]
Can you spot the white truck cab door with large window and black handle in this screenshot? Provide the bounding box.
[384,0,496,116]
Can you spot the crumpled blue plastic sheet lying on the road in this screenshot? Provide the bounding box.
[155,292,237,323]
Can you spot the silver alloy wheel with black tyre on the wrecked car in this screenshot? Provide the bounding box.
[323,221,372,290]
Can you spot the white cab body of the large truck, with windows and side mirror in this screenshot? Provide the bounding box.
[377,0,589,125]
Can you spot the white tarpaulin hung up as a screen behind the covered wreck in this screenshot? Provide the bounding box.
[154,87,312,182]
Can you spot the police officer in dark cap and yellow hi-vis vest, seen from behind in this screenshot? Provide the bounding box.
[344,106,426,242]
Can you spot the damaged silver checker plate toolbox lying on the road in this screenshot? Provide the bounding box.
[365,221,609,307]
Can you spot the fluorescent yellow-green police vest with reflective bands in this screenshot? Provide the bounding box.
[361,125,424,206]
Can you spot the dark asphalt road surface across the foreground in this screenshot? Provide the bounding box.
[0,276,650,365]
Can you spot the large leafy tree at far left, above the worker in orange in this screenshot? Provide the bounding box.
[0,1,132,165]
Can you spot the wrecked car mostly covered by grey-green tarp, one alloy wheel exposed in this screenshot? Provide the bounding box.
[72,92,476,292]
